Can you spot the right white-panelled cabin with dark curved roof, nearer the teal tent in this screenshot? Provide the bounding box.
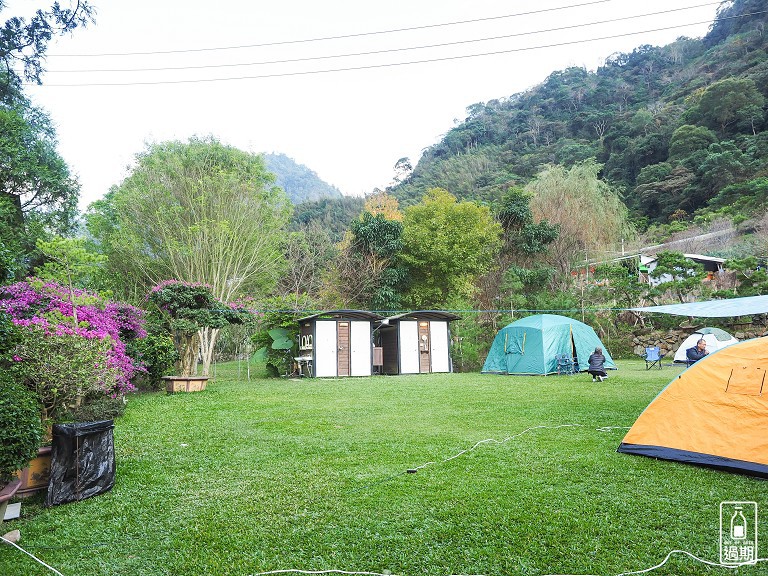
[376,310,460,374]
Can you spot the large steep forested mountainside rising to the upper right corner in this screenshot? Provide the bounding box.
[389,0,768,228]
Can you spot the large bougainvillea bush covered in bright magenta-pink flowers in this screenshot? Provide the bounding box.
[0,278,146,417]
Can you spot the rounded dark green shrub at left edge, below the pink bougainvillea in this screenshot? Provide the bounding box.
[0,371,42,487]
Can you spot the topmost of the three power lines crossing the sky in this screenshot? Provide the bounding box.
[49,0,612,58]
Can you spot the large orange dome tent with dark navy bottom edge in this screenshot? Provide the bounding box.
[618,337,768,478]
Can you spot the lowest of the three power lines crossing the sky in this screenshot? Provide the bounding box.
[33,10,752,88]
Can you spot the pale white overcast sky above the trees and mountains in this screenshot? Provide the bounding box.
[10,0,719,209]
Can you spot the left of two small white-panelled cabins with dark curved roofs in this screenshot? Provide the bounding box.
[295,310,383,378]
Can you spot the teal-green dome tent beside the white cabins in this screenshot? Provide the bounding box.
[482,314,616,374]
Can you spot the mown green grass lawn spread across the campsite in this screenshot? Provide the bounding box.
[0,361,768,576]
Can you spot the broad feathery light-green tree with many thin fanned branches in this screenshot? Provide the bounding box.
[89,137,291,306]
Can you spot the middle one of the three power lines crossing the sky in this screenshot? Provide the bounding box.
[48,2,719,74]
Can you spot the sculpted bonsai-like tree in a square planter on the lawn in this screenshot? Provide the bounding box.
[146,280,247,392]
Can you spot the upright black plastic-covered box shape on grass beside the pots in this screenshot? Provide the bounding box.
[45,420,115,506]
